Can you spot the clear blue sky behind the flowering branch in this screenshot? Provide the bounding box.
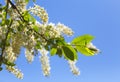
[0,0,120,82]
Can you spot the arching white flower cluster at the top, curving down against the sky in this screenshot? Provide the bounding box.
[28,4,48,23]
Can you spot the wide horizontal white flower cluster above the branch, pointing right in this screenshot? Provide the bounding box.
[36,21,74,38]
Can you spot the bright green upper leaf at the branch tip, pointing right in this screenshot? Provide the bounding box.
[71,34,94,46]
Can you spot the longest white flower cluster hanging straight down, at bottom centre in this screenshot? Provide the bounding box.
[39,48,51,76]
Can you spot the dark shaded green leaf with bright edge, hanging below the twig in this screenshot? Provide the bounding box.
[62,46,78,61]
